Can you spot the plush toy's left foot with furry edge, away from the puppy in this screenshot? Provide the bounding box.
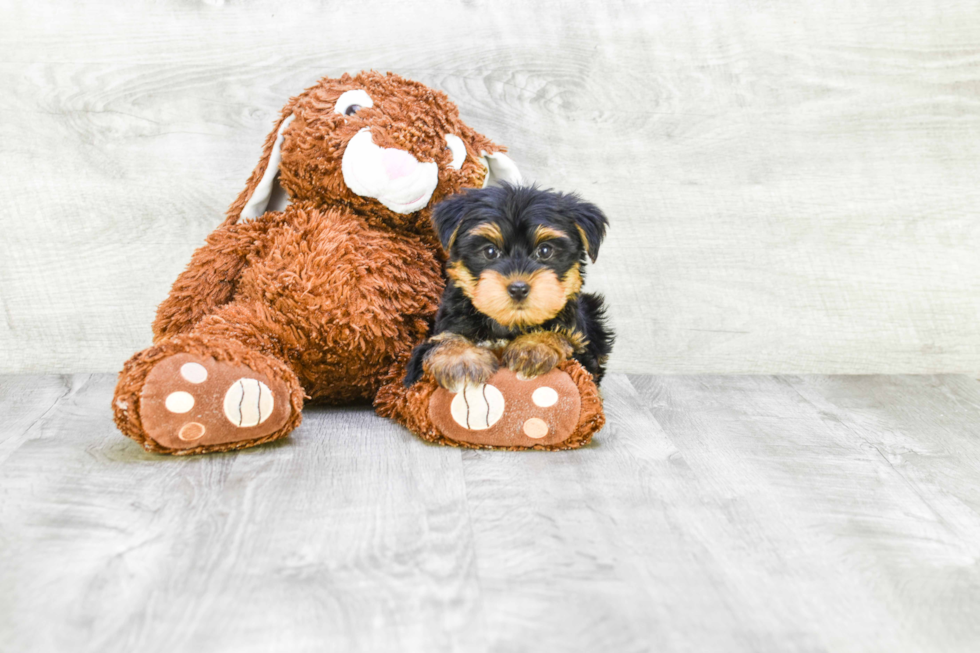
[113,310,303,454]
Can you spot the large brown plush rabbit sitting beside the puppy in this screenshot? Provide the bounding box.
[113,72,602,454]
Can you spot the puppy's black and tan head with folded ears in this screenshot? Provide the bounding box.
[433,185,607,329]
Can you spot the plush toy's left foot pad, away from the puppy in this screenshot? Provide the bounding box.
[139,353,292,449]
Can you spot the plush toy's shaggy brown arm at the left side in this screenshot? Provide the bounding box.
[153,219,270,342]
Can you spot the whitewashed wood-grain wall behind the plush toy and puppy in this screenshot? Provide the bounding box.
[0,0,980,373]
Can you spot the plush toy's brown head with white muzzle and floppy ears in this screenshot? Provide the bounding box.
[227,72,520,232]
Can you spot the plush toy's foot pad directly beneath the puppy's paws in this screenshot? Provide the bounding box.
[429,368,582,449]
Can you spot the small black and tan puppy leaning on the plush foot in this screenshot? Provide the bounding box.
[405,184,613,391]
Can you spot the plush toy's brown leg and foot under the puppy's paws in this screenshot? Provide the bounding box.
[375,356,605,450]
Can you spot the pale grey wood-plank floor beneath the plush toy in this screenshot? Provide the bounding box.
[0,375,980,653]
